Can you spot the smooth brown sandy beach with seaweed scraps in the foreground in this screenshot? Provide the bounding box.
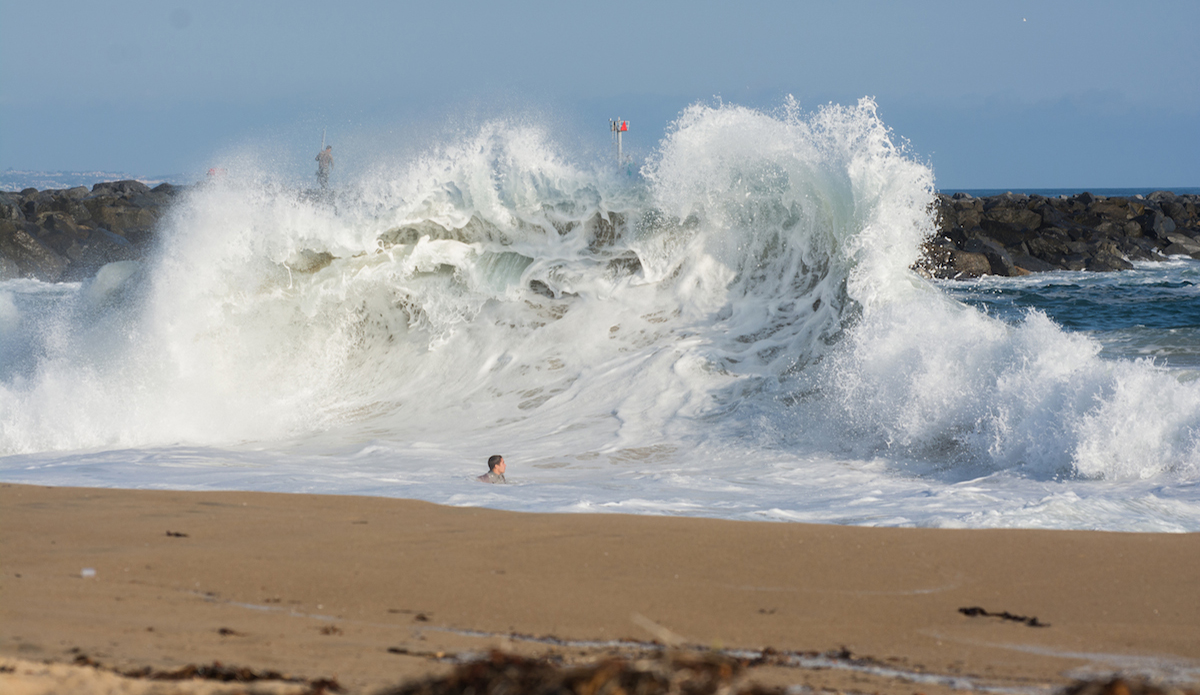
[0,484,1200,695]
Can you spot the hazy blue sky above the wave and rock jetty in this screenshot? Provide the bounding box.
[0,0,1200,188]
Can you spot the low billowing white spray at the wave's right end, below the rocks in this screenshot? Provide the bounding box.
[822,274,1200,480]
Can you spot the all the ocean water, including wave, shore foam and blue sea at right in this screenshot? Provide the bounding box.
[0,100,1200,532]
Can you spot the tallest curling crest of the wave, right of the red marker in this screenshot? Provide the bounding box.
[640,101,932,373]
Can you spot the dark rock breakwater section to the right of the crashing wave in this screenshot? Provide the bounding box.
[916,191,1200,278]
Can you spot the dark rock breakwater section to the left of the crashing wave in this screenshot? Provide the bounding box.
[0,181,182,282]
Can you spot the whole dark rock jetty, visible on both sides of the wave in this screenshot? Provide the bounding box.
[0,181,1200,282]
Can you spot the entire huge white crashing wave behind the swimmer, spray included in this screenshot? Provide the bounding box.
[0,100,1200,489]
